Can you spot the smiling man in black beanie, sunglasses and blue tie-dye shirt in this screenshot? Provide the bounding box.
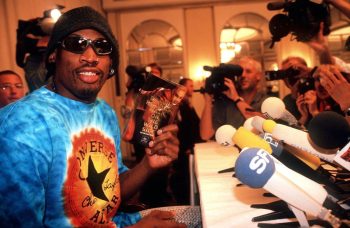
[0,7,184,227]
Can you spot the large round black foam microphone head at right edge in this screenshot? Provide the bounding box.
[307,111,350,149]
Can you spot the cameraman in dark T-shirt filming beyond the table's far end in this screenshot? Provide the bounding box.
[200,57,267,140]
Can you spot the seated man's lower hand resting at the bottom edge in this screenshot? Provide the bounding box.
[130,210,186,228]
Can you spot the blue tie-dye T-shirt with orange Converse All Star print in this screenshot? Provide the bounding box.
[0,87,140,227]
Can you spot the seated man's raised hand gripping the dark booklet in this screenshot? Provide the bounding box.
[145,124,179,169]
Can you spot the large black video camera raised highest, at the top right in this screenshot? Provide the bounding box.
[267,0,331,48]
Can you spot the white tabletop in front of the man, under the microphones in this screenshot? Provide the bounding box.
[194,142,295,228]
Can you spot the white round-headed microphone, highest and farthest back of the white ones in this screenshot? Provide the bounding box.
[261,97,298,126]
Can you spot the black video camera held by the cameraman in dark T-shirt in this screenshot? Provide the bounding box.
[202,63,243,96]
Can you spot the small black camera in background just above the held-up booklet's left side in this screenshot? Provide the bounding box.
[125,65,149,91]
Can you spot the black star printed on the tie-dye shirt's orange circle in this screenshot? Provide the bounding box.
[86,157,111,202]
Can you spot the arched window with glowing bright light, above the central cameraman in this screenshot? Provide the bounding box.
[220,13,279,96]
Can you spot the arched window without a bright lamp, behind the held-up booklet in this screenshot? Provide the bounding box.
[127,20,184,82]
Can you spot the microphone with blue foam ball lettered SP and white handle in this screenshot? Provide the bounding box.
[235,148,347,224]
